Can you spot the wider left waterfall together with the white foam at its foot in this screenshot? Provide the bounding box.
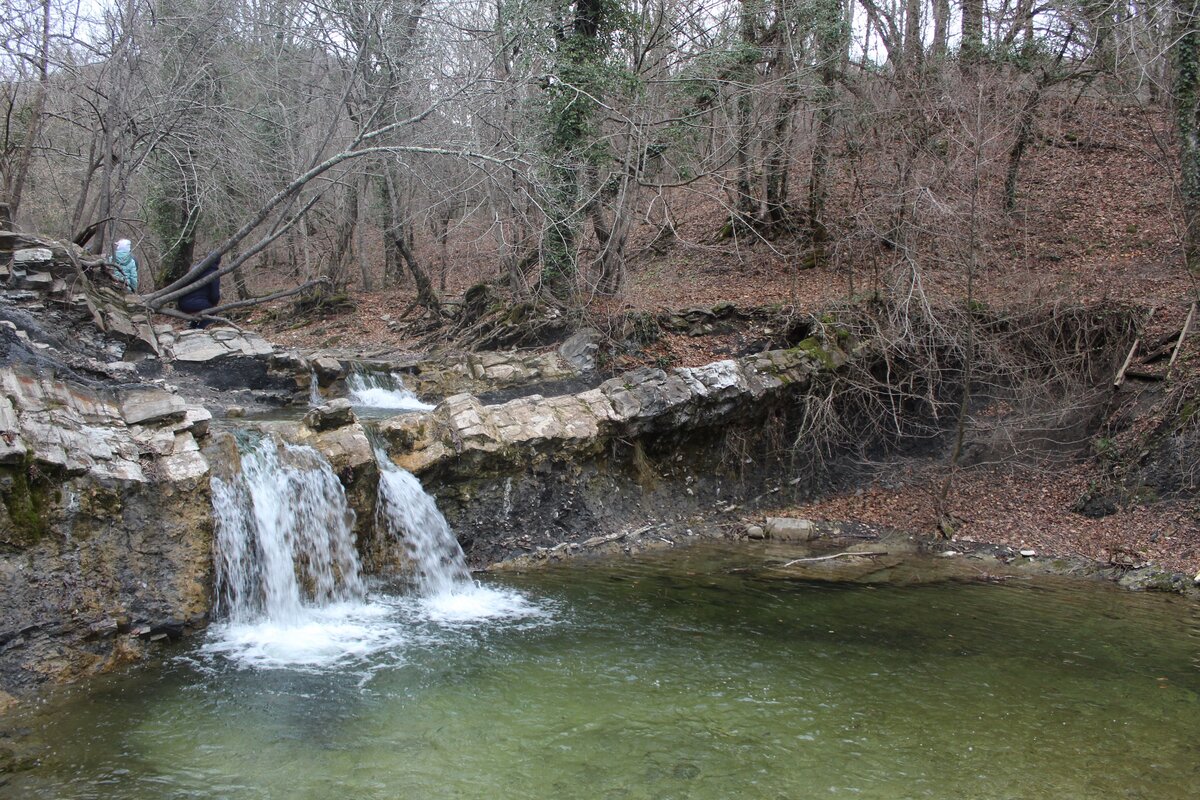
[204,438,402,667]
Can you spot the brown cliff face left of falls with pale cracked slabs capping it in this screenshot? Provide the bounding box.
[0,350,211,690]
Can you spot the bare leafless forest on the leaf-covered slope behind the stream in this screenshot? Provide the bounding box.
[0,0,1200,317]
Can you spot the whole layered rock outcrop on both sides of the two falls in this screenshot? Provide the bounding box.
[0,236,847,692]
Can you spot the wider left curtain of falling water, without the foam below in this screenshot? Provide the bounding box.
[212,438,365,625]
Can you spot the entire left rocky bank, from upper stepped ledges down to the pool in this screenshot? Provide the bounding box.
[0,246,294,708]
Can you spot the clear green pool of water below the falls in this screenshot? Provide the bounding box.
[0,546,1200,800]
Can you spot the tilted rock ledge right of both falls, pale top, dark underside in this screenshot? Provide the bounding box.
[380,342,848,566]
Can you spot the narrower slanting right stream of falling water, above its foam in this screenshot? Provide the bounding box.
[376,447,474,597]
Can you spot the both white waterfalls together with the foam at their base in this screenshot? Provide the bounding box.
[202,439,551,670]
